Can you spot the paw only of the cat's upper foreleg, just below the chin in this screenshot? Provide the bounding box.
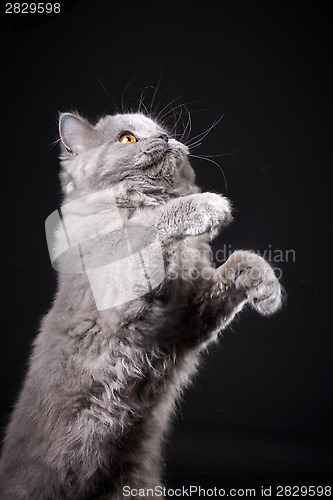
[185,193,232,237]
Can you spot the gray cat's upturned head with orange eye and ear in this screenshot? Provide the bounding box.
[59,113,196,198]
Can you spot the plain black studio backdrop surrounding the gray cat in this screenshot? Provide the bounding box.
[0,0,333,487]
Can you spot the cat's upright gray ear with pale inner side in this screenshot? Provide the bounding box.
[59,113,95,155]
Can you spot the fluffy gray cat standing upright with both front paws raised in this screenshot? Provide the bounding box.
[0,113,281,500]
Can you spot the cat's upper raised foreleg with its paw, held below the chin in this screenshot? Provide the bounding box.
[154,193,232,241]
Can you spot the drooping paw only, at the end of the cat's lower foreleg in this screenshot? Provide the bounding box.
[221,250,282,315]
